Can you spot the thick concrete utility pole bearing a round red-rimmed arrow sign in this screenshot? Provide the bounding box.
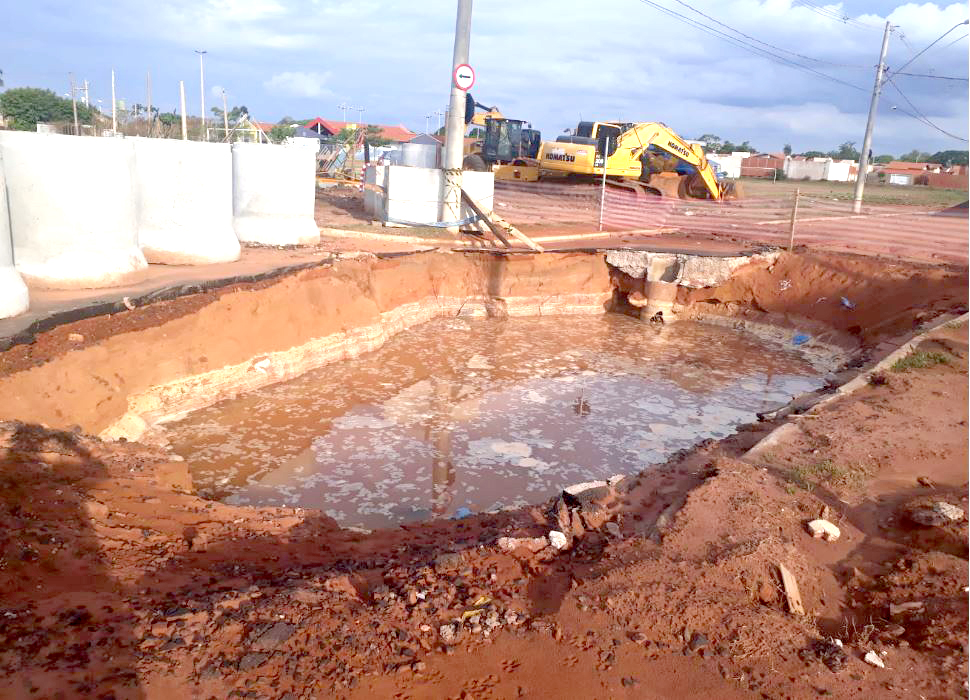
[441,0,472,235]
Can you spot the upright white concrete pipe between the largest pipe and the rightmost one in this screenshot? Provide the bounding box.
[132,138,239,265]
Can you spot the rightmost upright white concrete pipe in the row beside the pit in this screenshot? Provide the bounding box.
[232,143,320,245]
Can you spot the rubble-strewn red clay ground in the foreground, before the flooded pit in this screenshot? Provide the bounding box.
[0,326,968,700]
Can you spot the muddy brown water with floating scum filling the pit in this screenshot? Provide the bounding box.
[167,314,822,528]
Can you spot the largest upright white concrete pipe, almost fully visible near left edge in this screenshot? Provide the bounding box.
[0,131,147,289]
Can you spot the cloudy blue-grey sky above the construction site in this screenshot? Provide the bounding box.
[0,0,968,155]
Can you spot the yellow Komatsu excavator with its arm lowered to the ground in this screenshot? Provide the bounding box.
[539,122,740,201]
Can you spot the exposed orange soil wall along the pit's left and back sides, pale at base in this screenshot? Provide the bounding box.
[0,253,610,438]
